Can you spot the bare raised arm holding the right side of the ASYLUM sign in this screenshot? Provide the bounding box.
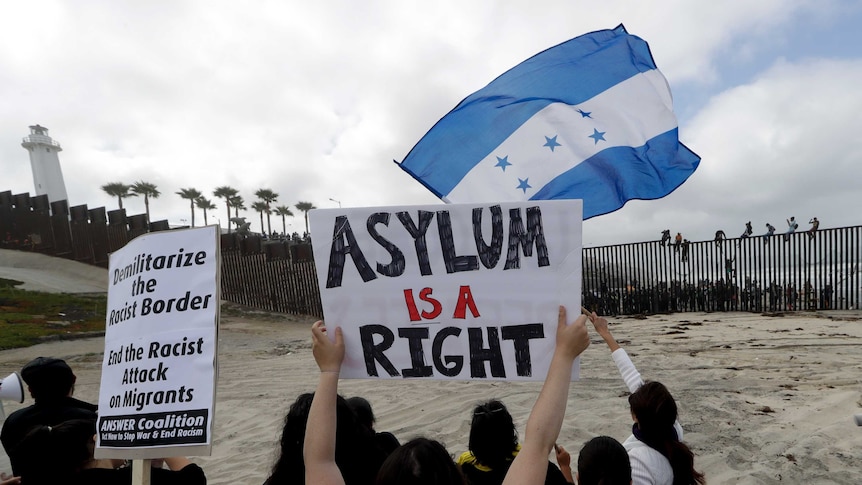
[503,306,590,485]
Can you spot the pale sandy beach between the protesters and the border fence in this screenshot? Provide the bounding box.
[0,251,862,484]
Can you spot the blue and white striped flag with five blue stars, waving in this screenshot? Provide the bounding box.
[400,25,700,219]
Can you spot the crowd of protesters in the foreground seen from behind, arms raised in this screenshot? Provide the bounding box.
[0,307,705,485]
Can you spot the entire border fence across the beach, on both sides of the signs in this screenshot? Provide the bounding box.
[0,191,862,317]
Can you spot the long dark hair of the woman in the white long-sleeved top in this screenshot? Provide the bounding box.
[629,381,706,485]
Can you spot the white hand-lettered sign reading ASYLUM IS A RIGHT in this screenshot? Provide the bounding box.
[309,200,582,380]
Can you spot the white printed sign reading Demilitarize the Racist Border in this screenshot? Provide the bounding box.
[96,226,220,458]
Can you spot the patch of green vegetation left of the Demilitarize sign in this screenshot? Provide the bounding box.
[0,278,107,350]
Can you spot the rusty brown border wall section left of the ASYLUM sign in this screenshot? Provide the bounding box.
[0,191,323,317]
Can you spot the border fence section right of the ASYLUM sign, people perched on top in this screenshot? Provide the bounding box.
[583,226,862,315]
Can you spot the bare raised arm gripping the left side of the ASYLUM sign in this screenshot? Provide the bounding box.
[303,321,344,485]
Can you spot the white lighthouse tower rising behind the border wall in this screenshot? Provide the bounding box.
[21,125,68,202]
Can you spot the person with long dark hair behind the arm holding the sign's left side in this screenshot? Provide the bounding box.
[264,393,386,485]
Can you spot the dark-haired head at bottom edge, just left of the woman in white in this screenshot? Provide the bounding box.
[577,436,632,485]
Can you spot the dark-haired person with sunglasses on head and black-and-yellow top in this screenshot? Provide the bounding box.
[458,400,569,485]
